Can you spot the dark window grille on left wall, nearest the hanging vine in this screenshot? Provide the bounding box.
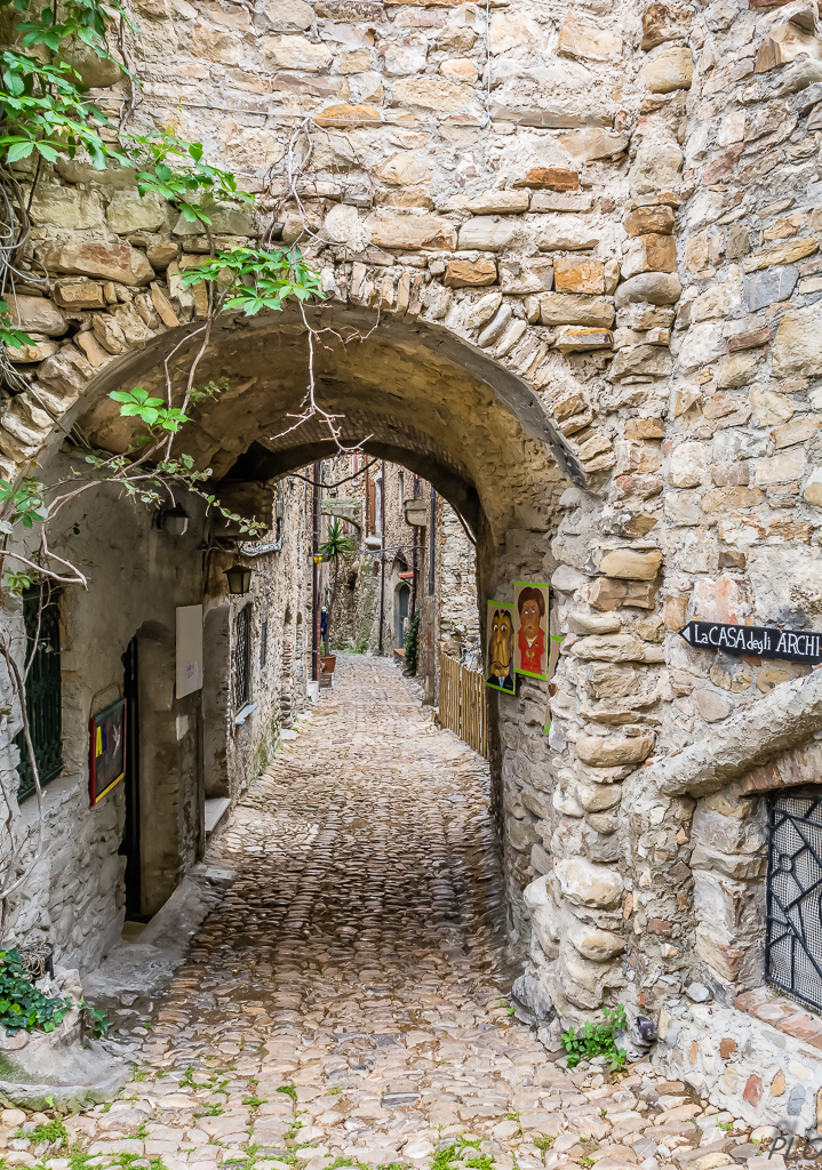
[14,590,63,801]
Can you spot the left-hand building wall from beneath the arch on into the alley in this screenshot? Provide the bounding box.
[2,456,306,970]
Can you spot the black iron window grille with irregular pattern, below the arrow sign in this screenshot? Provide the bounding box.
[765,792,822,1011]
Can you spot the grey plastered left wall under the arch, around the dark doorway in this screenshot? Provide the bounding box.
[0,460,209,966]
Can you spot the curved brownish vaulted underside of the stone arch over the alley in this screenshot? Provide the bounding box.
[57,304,586,540]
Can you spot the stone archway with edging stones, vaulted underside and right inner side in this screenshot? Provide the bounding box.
[2,251,659,1038]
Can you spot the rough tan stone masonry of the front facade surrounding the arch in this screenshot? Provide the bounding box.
[0,0,822,1130]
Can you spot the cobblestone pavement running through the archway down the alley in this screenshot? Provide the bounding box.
[0,656,767,1170]
